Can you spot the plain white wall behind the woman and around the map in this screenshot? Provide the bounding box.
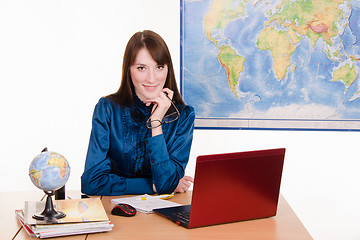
[0,0,360,240]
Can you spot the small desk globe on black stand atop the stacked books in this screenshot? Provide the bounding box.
[29,148,70,221]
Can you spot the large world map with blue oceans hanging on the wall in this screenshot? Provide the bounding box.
[181,0,360,128]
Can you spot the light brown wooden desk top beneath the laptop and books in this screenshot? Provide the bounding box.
[9,191,312,240]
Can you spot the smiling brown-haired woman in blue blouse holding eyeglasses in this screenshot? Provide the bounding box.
[81,30,195,195]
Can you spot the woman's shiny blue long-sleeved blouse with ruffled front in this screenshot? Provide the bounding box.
[81,97,195,195]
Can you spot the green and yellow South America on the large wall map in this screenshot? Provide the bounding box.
[219,45,245,96]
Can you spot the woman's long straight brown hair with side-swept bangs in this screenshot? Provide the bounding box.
[108,30,184,105]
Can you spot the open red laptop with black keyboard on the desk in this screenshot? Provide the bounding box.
[154,148,285,228]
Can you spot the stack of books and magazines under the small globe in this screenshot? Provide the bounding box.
[15,198,114,238]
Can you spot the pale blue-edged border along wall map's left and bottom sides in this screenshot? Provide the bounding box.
[180,0,360,131]
